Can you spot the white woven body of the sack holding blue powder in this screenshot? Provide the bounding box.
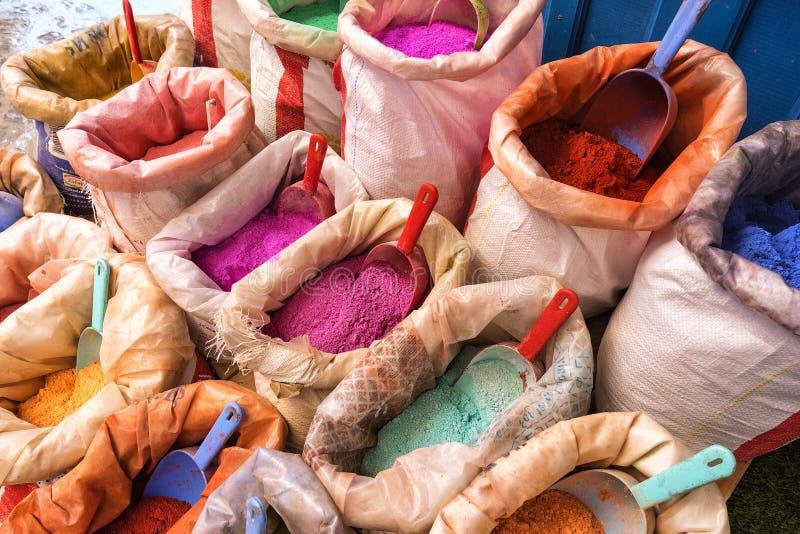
[595,226,800,460]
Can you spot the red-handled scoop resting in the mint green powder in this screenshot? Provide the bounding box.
[453,288,578,391]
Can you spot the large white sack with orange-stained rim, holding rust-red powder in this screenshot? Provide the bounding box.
[466,41,746,317]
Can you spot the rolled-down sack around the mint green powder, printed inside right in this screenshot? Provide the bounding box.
[303,276,594,533]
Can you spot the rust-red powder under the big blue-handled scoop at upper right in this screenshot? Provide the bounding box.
[521,119,666,202]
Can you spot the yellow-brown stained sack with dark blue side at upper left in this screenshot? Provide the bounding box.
[0,15,194,215]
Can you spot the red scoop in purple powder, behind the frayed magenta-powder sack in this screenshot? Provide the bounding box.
[278,134,336,220]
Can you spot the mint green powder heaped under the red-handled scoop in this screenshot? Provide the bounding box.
[361,347,522,476]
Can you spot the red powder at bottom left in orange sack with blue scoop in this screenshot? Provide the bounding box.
[98,497,192,534]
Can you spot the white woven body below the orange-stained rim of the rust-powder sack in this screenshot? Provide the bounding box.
[464,167,650,317]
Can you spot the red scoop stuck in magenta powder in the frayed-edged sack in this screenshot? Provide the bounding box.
[361,184,439,313]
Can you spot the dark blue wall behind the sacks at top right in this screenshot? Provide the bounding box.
[542,0,800,137]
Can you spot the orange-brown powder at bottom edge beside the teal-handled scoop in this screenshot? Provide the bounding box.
[492,490,605,534]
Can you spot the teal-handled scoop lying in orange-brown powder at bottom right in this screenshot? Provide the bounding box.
[550,445,736,534]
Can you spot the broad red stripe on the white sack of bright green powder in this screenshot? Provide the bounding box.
[275,46,308,139]
